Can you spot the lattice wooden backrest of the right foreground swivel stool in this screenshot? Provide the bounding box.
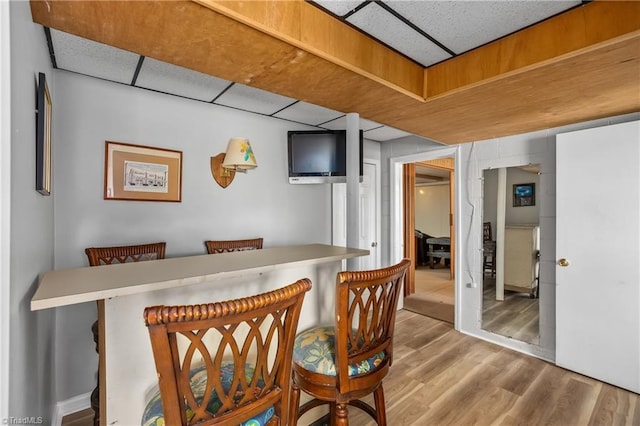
[335,259,411,393]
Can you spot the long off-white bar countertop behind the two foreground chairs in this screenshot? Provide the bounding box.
[31,244,369,311]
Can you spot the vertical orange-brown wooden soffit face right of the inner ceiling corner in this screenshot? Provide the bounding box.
[426,1,640,99]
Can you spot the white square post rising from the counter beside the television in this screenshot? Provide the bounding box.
[347,112,360,270]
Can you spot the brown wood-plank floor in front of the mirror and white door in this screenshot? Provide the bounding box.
[63,310,640,426]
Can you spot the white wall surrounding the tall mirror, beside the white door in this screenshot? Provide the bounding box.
[457,114,638,361]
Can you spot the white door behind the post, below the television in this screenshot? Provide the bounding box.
[332,163,380,269]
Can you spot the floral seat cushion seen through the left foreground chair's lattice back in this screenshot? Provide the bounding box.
[141,362,275,426]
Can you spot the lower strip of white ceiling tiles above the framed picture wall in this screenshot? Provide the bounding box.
[46,29,410,141]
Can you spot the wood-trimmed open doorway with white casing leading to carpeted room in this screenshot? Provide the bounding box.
[391,147,459,325]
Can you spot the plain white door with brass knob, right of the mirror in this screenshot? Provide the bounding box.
[556,121,640,392]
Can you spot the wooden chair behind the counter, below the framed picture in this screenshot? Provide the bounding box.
[84,242,167,426]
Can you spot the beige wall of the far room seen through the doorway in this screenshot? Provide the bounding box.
[415,185,449,237]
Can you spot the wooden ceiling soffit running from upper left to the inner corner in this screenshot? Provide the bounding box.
[31,0,424,110]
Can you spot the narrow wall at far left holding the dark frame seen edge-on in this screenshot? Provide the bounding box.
[8,2,57,424]
